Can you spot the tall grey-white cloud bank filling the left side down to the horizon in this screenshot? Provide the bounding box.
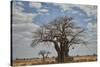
[12,2,39,58]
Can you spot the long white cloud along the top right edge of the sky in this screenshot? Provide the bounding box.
[53,4,97,16]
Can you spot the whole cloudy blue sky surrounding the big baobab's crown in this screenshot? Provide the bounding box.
[12,1,97,58]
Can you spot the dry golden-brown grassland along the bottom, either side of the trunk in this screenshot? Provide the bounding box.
[12,55,97,66]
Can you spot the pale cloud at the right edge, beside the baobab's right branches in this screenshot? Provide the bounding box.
[84,22,97,46]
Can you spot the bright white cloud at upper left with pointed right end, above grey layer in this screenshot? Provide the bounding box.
[13,11,38,23]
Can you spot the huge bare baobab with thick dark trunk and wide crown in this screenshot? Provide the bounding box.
[31,16,86,63]
